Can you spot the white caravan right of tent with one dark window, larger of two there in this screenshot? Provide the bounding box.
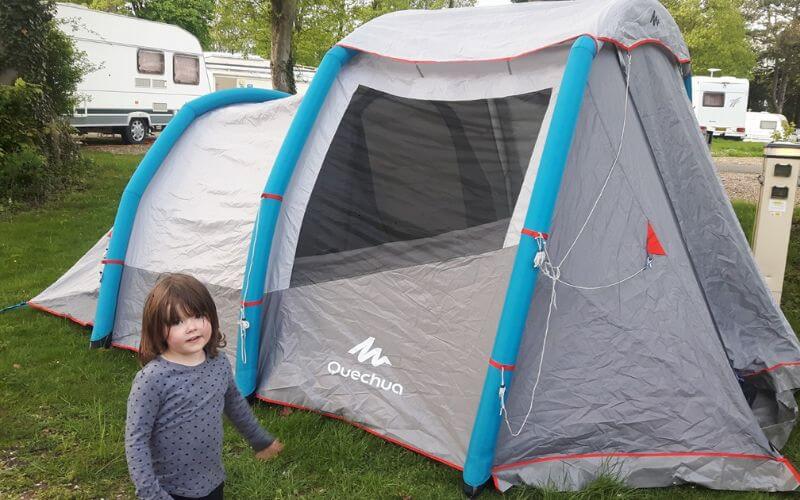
[692,76,750,139]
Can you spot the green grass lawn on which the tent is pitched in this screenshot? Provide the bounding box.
[0,153,800,500]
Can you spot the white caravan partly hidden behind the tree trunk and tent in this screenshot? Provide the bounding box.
[204,52,317,94]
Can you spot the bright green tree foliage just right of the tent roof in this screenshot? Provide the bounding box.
[662,0,756,78]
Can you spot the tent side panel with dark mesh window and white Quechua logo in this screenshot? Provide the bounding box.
[257,87,551,467]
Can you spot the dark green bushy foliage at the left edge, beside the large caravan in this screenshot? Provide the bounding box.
[0,0,86,211]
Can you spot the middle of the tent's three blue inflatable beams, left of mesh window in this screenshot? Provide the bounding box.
[236,46,356,396]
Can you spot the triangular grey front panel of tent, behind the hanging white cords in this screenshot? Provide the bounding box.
[494,50,797,490]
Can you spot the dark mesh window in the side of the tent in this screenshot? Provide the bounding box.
[291,86,551,286]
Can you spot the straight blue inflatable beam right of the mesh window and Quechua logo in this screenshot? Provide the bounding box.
[463,36,597,496]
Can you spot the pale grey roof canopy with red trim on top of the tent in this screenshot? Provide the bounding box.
[339,0,689,62]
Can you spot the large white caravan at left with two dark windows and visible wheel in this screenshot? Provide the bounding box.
[56,3,209,143]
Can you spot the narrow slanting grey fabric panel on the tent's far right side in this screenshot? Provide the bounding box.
[631,47,800,448]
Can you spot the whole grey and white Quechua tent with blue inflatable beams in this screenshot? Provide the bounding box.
[30,0,800,494]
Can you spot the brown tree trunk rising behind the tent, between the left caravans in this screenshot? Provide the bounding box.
[270,0,297,94]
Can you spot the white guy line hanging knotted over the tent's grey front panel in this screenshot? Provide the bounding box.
[498,51,636,437]
